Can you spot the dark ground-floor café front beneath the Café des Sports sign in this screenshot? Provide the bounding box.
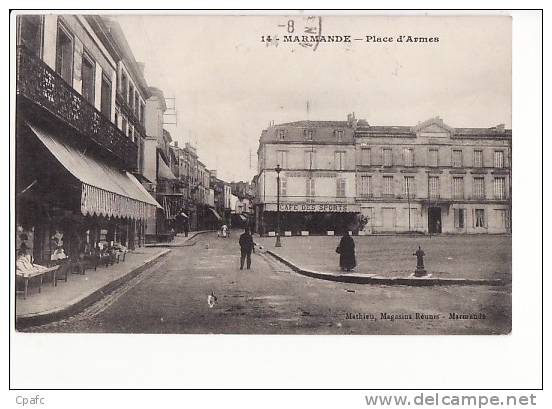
[259,202,360,236]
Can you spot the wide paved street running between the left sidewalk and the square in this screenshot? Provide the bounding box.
[28,231,511,334]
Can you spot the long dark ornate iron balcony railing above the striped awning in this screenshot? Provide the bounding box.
[17,46,138,170]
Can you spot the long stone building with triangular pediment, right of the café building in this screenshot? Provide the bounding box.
[355,117,512,234]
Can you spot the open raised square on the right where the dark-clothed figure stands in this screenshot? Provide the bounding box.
[255,236,511,286]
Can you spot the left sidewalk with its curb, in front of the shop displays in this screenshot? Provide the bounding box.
[15,247,170,328]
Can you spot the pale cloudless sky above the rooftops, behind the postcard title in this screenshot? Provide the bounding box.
[115,15,512,181]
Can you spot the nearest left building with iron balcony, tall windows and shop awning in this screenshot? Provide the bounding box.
[15,14,159,263]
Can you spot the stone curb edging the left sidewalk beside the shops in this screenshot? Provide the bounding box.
[15,249,171,331]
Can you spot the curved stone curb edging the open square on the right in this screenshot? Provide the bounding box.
[266,250,506,287]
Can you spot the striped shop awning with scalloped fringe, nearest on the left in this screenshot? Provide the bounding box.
[27,123,162,219]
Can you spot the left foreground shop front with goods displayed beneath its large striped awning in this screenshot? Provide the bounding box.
[16,121,160,264]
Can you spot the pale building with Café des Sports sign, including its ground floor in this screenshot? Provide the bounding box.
[255,116,360,235]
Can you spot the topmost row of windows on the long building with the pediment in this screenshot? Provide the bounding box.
[360,148,505,168]
